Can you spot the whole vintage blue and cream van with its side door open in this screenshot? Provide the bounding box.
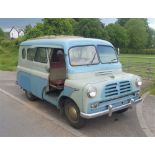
[17,38,142,128]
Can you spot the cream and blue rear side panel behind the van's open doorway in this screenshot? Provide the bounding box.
[17,47,49,99]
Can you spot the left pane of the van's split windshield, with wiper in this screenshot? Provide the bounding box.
[69,46,99,66]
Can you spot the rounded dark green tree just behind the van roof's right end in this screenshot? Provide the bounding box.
[105,24,129,48]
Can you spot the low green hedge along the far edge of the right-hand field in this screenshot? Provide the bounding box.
[120,48,155,55]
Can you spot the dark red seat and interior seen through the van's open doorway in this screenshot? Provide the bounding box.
[49,48,66,92]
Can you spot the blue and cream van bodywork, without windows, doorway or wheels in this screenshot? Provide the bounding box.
[17,38,142,119]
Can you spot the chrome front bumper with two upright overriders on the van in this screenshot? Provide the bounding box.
[80,98,142,119]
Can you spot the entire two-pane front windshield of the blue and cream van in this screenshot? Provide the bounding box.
[69,45,118,66]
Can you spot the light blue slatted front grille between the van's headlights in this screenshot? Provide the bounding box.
[104,81,131,97]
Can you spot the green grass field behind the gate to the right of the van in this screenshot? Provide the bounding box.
[119,54,155,95]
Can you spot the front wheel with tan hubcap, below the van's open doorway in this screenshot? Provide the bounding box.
[64,99,85,129]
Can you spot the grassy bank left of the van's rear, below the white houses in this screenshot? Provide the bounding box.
[0,46,18,71]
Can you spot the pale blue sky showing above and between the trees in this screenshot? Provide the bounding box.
[0,18,155,31]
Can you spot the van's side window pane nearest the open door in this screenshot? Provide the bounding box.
[34,47,47,63]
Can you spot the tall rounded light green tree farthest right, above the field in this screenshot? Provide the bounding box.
[125,19,148,49]
